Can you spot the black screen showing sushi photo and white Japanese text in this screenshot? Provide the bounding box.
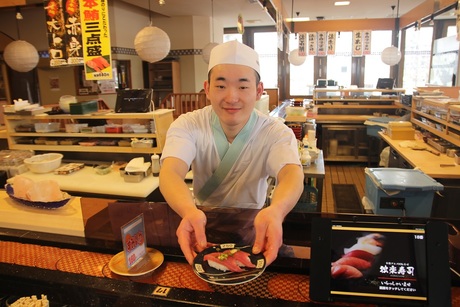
[331,227,427,300]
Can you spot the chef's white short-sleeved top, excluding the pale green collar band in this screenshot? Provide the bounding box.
[161,106,300,209]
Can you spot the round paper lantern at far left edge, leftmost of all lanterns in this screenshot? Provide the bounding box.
[3,40,39,72]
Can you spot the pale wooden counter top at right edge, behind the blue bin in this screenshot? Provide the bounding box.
[379,132,460,179]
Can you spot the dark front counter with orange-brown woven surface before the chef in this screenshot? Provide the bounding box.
[0,198,460,307]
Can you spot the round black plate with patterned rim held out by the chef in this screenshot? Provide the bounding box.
[193,243,266,285]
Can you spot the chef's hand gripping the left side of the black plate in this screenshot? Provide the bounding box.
[176,209,207,264]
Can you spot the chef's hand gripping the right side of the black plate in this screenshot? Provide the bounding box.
[252,207,284,265]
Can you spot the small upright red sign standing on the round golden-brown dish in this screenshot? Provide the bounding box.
[121,213,147,270]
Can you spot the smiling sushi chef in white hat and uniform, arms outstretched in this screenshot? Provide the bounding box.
[160,41,303,264]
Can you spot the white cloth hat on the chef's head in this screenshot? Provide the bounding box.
[208,40,260,76]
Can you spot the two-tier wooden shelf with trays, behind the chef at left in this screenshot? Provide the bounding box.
[5,109,174,154]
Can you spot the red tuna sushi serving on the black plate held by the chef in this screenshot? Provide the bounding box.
[203,248,256,272]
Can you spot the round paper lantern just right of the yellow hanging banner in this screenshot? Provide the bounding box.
[134,26,171,63]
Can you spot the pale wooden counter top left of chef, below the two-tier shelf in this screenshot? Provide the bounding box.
[8,166,159,198]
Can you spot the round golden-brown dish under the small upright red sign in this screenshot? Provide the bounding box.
[109,248,164,276]
